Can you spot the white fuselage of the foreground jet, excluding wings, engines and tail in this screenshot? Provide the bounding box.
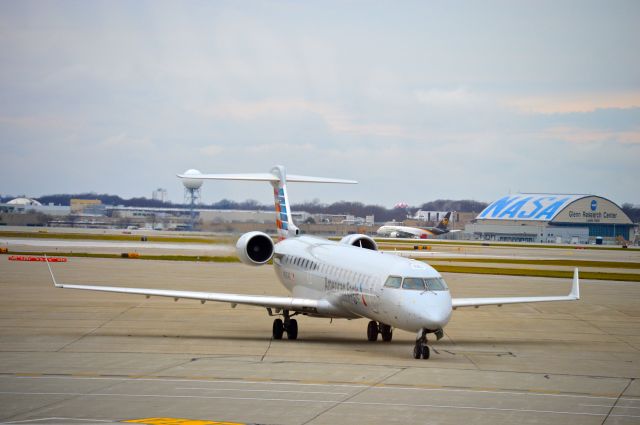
[273,236,451,332]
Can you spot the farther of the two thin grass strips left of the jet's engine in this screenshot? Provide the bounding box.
[0,231,232,244]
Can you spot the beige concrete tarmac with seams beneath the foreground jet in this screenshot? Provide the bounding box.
[0,256,640,425]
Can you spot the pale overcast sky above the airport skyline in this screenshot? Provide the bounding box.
[0,0,640,207]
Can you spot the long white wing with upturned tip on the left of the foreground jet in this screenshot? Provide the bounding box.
[47,262,320,311]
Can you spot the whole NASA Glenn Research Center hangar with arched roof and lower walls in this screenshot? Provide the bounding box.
[465,193,634,244]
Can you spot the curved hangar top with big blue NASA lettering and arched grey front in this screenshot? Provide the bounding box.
[476,193,631,224]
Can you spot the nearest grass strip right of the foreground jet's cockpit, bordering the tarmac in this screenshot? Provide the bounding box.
[433,265,640,282]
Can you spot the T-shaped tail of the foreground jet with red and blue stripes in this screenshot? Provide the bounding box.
[178,165,358,240]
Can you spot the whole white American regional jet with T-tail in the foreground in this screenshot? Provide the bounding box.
[47,166,580,359]
